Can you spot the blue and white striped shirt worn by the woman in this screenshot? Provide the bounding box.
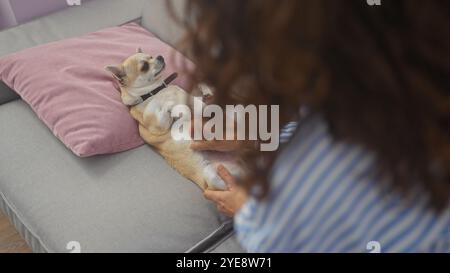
[235,114,450,252]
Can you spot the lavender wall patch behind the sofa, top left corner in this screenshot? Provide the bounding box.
[0,0,87,29]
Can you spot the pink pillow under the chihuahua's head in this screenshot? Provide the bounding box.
[0,23,192,157]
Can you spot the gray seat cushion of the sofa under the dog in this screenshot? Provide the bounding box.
[0,101,225,252]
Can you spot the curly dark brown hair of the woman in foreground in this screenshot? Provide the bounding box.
[169,0,450,209]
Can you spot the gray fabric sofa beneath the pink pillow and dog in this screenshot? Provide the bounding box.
[0,0,242,252]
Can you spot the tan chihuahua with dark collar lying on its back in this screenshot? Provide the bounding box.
[105,49,242,190]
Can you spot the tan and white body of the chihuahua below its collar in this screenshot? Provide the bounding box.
[135,87,243,190]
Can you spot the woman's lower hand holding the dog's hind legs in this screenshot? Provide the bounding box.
[204,165,248,217]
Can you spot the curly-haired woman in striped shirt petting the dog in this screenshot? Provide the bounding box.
[178,0,450,252]
